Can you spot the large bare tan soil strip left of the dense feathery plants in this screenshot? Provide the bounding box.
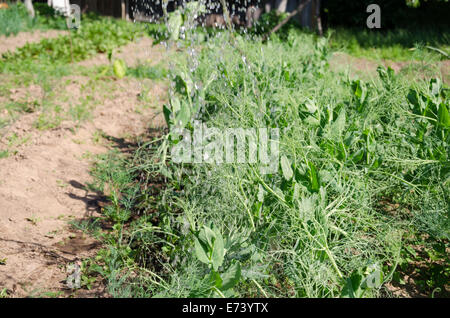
[0,40,166,297]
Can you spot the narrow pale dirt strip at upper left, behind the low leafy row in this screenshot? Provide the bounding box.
[0,30,67,56]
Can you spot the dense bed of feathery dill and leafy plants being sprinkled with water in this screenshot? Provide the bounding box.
[87,27,450,297]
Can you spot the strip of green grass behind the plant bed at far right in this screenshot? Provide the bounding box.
[330,28,450,61]
